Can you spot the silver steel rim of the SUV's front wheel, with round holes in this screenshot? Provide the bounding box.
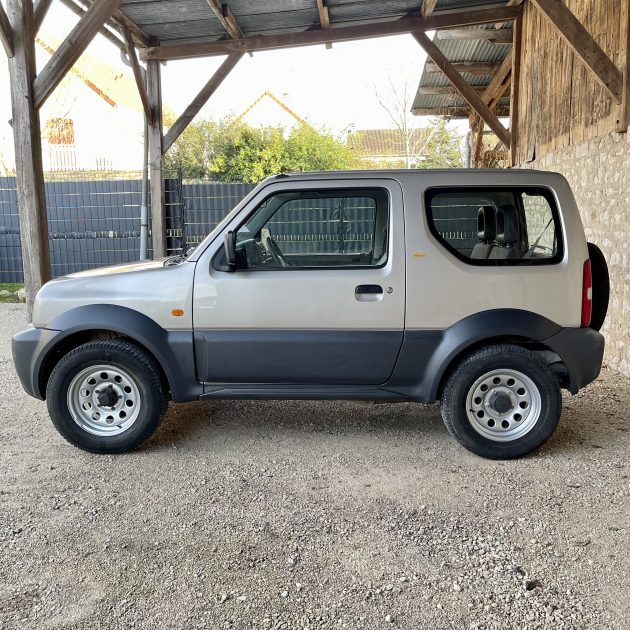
[67,364,142,437]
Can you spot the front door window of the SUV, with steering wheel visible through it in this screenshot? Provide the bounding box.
[236,188,389,270]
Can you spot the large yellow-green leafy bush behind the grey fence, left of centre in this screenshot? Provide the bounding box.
[165,119,355,183]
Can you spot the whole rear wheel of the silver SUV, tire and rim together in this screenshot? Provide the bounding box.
[442,344,562,459]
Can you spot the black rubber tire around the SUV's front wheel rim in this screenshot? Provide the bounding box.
[46,339,168,453]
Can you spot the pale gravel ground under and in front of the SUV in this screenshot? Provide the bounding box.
[0,304,630,630]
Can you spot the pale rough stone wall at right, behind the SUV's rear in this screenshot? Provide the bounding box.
[525,133,630,376]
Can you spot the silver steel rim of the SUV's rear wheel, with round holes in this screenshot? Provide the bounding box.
[466,369,542,442]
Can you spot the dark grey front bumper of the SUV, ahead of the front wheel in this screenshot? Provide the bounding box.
[11,324,62,400]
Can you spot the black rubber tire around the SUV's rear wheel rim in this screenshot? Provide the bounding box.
[441,344,562,459]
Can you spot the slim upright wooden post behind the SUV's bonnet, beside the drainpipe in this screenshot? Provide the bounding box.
[147,50,166,258]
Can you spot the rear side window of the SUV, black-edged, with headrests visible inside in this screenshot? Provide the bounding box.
[426,187,562,265]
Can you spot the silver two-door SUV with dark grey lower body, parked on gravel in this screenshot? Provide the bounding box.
[13,170,607,458]
